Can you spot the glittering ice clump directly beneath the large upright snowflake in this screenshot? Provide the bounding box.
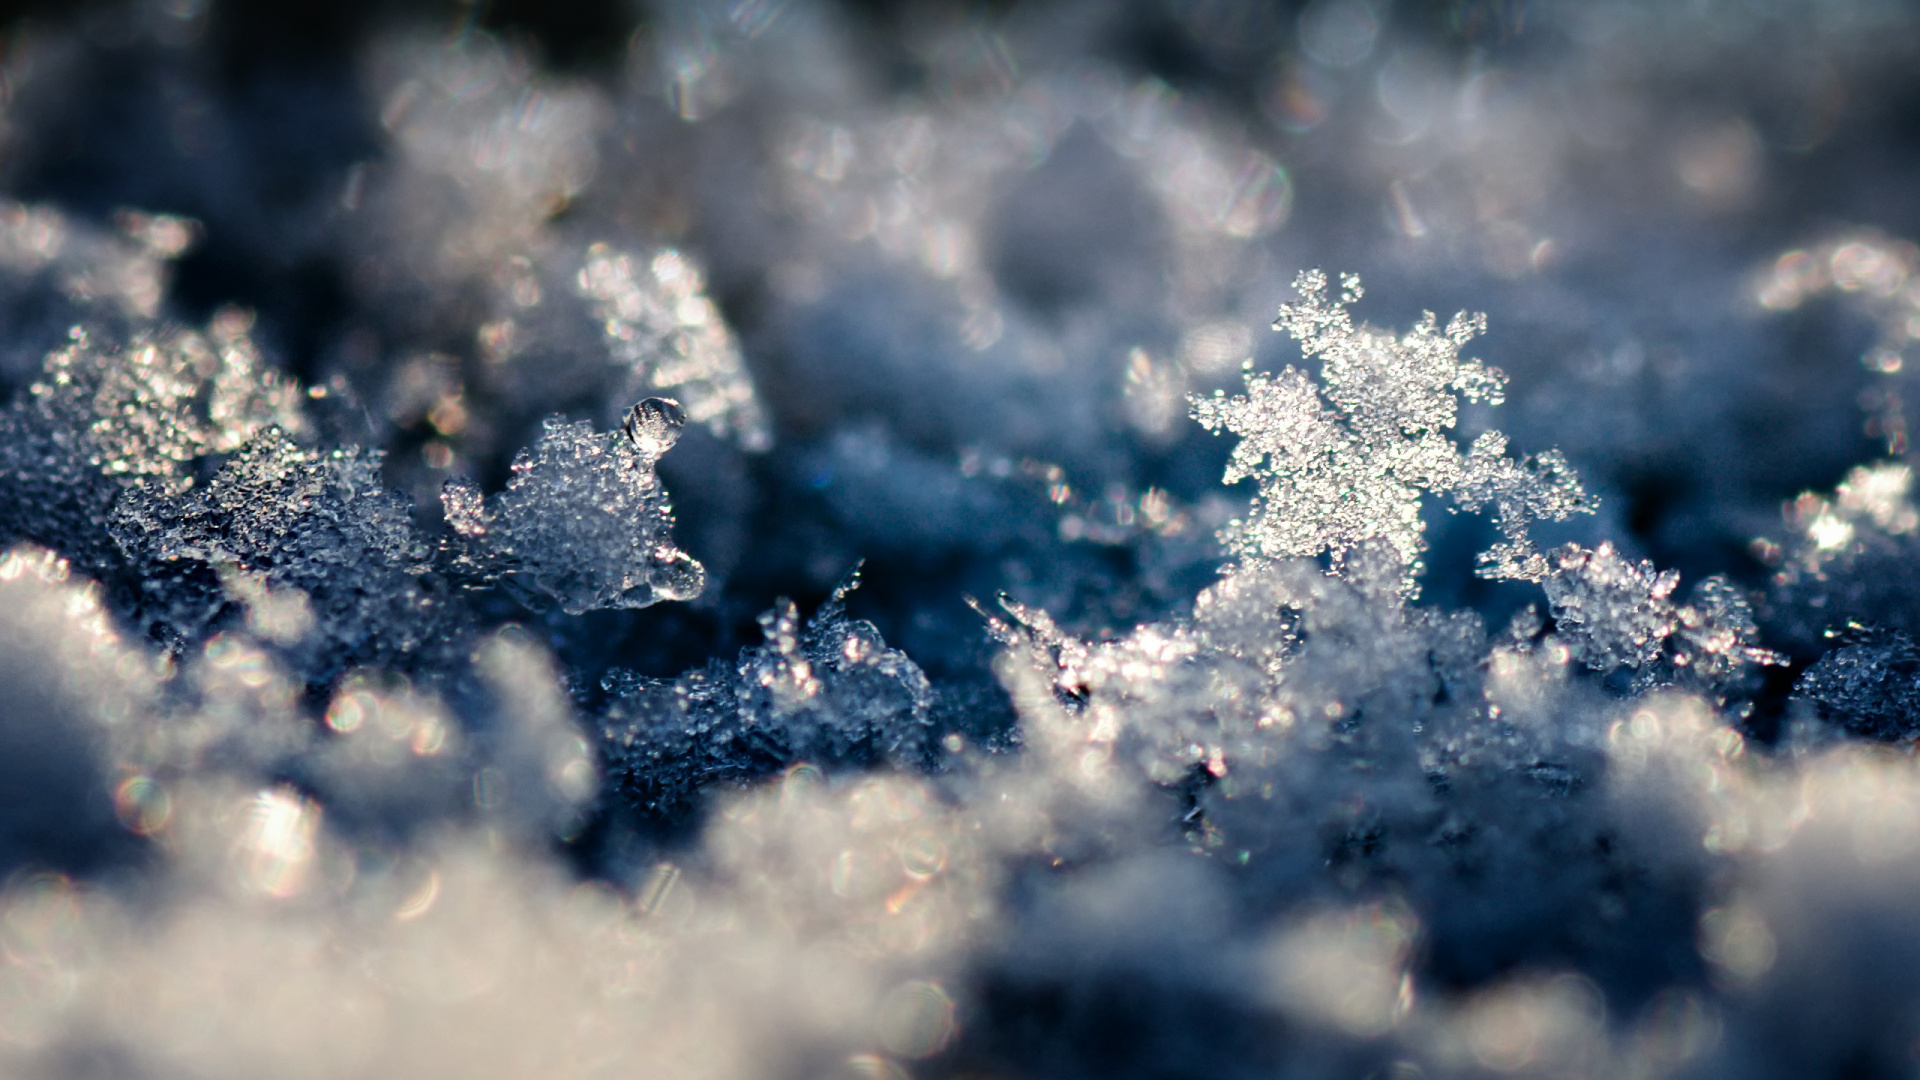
[993,545,1486,784]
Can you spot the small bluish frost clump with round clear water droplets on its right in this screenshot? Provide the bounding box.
[440,398,707,615]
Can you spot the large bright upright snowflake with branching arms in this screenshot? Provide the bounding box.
[1192,271,1592,594]
